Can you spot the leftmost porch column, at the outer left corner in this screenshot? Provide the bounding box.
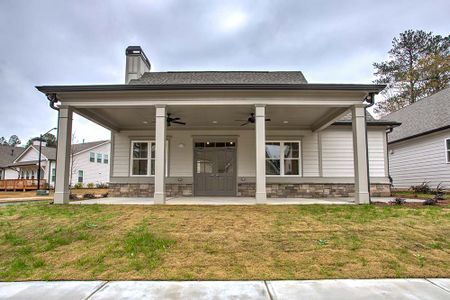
[53,107,72,204]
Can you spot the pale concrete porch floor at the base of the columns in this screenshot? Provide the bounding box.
[70,197,423,205]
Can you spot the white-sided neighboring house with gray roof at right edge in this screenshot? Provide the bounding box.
[383,87,450,189]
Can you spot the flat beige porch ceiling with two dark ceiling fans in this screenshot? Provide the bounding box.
[76,105,343,130]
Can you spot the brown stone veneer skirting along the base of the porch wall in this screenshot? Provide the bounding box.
[109,183,391,198]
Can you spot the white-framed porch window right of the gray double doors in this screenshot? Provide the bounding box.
[266,141,301,176]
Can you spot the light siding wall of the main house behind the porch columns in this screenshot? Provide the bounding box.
[111,126,387,183]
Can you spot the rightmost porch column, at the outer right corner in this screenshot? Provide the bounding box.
[352,105,370,204]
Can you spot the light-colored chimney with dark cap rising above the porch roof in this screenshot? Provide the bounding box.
[125,46,151,84]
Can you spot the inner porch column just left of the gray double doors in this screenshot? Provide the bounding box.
[153,105,166,204]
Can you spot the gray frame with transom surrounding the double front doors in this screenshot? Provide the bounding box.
[192,135,239,197]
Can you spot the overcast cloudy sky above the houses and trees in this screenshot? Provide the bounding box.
[0,0,450,143]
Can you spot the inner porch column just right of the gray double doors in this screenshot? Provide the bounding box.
[255,104,267,203]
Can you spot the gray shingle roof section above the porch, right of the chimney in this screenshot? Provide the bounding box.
[129,71,308,85]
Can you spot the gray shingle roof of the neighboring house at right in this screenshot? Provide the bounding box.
[381,87,450,142]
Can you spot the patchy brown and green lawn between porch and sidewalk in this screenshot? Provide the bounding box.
[0,204,450,280]
